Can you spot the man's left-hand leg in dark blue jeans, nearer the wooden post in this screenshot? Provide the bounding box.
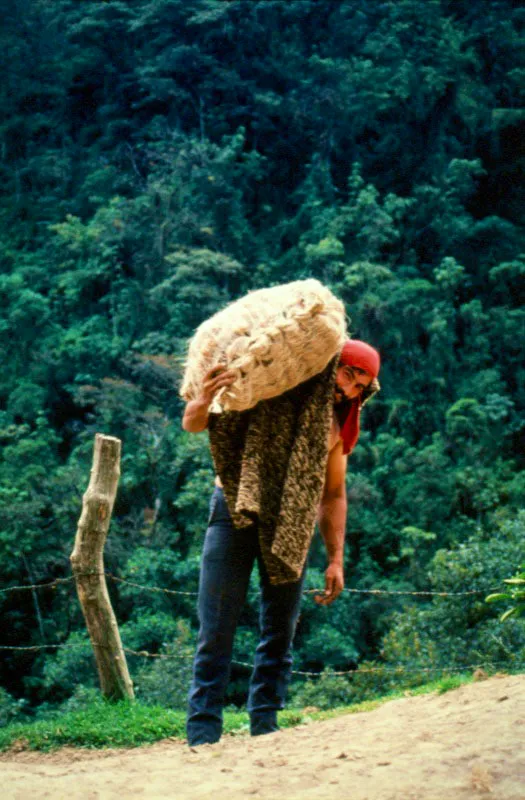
[186,488,257,745]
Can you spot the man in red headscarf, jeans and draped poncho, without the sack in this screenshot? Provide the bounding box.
[182,339,380,746]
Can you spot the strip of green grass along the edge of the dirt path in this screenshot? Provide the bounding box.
[0,674,500,751]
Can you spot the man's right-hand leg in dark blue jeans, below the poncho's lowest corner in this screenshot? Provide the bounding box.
[248,558,306,736]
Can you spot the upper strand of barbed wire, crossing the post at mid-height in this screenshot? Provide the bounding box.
[0,571,498,597]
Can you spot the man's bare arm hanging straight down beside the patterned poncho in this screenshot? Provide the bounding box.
[315,441,347,605]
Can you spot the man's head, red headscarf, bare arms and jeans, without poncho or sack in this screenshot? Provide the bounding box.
[182,339,380,746]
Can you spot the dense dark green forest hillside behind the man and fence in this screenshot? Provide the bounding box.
[0,0,525,721]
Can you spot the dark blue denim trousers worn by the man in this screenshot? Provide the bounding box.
[186,486,305,745]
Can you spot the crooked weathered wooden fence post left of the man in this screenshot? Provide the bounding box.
[71,433,134,700]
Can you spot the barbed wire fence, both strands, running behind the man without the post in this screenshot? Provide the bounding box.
[0,571,525,679]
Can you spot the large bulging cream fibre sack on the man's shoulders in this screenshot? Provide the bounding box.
[180,278,346,413]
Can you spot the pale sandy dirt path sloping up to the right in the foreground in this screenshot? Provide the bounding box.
[0,675,525,800]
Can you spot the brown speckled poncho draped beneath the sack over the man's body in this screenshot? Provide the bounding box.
[208,356,338,584]
